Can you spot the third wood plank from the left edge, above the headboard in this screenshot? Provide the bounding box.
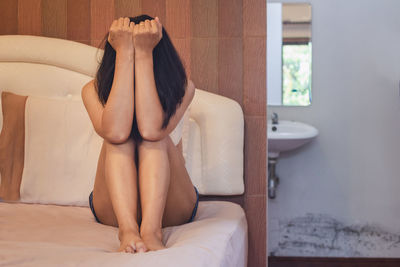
[42,0,67,39]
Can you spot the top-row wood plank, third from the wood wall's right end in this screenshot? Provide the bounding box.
[192,0,218,38]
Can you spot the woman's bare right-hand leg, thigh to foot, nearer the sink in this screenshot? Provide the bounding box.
[138,136,196,250]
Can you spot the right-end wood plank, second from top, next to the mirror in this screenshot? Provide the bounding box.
[243,37,267,116]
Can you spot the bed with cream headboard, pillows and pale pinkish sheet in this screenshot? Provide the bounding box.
[0,35,248,266]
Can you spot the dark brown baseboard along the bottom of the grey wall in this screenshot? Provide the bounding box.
[268,257,400,267]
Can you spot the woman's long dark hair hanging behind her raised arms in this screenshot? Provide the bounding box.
[95,15,187,142]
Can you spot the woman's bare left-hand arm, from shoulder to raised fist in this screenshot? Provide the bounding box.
[81,18,134,143]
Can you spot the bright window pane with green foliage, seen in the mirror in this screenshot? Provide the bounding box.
[282,42,311,106]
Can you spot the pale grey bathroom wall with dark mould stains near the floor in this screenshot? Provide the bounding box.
[268,0,400,257]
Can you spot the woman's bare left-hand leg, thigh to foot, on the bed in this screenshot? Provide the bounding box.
[93,139,147,252]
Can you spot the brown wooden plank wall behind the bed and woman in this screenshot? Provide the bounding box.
[0,0,267,266]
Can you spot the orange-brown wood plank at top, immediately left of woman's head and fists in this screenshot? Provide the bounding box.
[90,0,114,47]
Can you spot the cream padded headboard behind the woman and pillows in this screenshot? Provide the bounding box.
[0,35,244,195]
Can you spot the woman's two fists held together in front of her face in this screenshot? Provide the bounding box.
[108,17,162,53]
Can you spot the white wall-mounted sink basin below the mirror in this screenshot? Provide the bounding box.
[268,120,318,158]
